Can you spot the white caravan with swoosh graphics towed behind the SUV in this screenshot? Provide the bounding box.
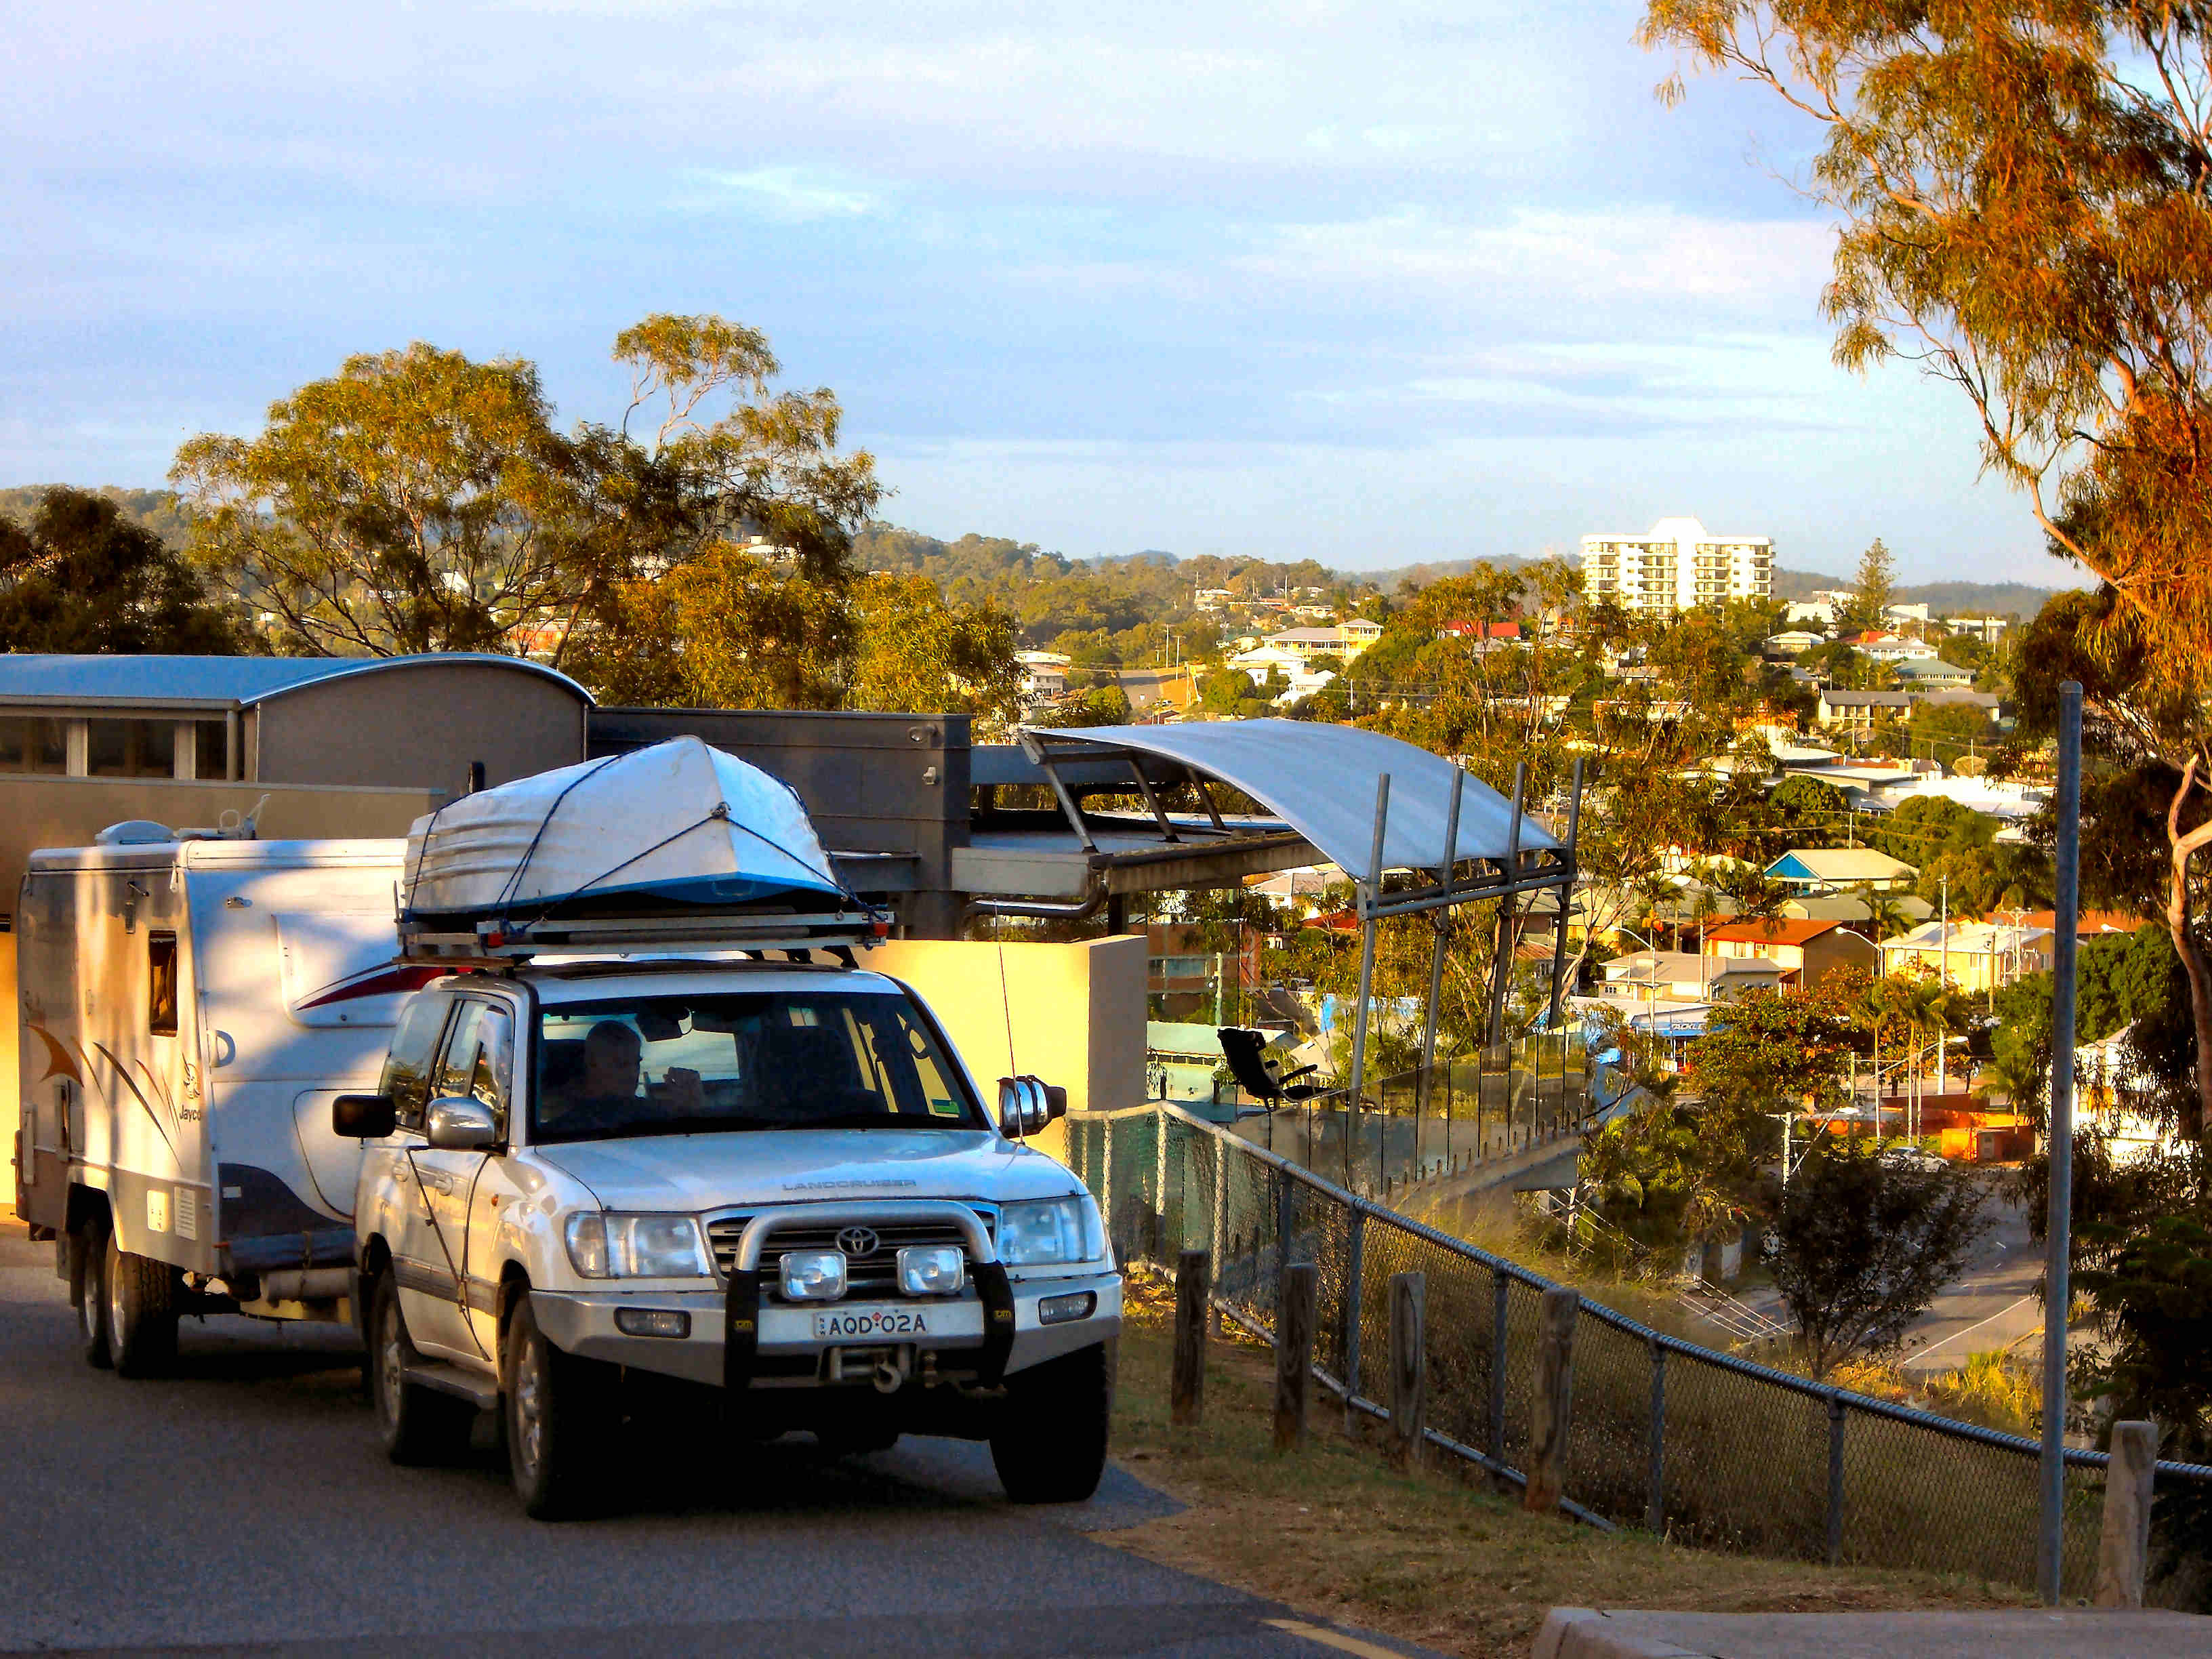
[16,823,434,1374]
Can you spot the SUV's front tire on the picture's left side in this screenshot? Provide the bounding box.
[500,1290,621,1519]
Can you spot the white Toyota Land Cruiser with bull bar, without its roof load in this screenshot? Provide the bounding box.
[334,960,1122,1519]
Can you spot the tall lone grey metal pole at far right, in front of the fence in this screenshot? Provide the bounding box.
[2035,679,2081,1608]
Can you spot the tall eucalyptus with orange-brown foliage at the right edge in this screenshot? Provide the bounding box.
[1641,0,2212,1137]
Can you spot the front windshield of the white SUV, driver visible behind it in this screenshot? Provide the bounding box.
[531,989,987,1141]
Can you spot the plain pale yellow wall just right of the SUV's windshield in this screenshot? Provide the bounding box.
[861,933,1146,1113]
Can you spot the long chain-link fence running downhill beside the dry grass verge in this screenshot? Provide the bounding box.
[1069,1104,2212,1597]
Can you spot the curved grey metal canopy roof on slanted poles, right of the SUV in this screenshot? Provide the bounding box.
[1017,719,1559,880]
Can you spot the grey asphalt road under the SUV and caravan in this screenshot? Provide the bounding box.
[0,1228,1409,1659]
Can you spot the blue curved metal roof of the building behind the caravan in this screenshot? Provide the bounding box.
[0,651,593,708]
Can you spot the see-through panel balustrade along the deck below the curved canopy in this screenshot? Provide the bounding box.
[1234,1031,1593,1199]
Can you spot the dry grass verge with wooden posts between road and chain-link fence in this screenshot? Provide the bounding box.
[1101,1276,2026,1657]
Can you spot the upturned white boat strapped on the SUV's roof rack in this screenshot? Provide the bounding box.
[401,737,845,924]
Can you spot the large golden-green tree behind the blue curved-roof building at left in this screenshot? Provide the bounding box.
[170,314,882,663]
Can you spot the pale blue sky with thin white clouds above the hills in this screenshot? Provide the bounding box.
[0,0,2068,584]
